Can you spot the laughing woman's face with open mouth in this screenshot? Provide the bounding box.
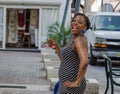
[71,15,86,35]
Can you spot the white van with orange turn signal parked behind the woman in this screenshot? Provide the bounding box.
[85,12,120,65]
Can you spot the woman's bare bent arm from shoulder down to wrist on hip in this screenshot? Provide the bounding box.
[74,37,89,85]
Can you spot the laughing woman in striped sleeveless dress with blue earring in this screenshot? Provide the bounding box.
[48,13,90,94]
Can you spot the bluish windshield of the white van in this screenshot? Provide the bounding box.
[94,15,120,31]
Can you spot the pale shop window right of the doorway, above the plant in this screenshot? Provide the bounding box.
[41,8,58,43]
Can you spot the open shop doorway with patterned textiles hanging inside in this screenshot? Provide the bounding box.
[5,8,39,49]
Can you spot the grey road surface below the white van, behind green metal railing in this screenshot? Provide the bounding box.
[86,60,120,94]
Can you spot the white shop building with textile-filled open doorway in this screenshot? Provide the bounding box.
[0,0,71,50]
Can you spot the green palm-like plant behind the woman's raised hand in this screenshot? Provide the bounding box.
[48,22,71,47]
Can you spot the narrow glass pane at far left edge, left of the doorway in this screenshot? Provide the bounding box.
[0,8,3,48]
